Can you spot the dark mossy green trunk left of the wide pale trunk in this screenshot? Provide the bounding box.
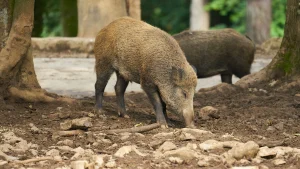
[60,0,78,37]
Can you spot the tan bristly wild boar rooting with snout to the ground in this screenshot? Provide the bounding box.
[94,17,197,127]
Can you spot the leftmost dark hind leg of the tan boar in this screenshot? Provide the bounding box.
[95,70,113,113]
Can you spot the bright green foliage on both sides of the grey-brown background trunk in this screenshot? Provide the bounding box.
[205,0,286,37]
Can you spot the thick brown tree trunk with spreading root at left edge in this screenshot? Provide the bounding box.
[0,0,54,102]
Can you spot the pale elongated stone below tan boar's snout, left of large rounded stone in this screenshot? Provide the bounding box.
[163,147,197,161]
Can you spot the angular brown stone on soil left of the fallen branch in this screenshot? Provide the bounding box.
[60,117,92,130]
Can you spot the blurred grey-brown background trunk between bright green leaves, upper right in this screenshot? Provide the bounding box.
[247,0,272,44]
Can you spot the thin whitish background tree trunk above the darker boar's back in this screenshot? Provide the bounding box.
[190,0,210,31]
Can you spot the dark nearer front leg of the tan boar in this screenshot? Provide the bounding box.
[144,88,168,128]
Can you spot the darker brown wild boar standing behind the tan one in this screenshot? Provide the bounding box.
[173,29,255,84]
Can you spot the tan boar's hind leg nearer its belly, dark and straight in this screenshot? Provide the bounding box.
[115,73,129,118]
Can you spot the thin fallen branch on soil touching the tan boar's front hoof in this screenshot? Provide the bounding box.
[105,123,160,134]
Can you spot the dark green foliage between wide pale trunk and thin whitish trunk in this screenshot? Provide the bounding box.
[141,0,191,34]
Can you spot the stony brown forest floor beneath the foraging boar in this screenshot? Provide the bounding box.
[0,41,300,169]
